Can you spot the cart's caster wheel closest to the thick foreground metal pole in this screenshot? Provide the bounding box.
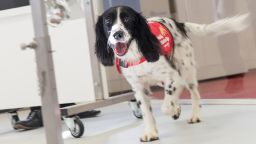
[64,116,84,138]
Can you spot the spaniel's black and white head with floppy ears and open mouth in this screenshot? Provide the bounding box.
[95,6,159,66]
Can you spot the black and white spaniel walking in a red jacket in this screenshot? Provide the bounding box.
[96,6,248,141]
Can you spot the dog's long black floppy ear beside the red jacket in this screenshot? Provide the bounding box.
[134,13,160,62]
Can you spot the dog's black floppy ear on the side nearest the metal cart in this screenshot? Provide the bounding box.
[95,16,114,66]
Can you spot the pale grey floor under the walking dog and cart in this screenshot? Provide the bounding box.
[0,100,256,144]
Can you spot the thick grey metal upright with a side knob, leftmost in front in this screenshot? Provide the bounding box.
[30,0,63,144]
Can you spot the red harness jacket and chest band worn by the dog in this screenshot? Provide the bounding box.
[115,21,174,73]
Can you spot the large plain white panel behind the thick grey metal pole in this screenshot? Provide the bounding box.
[0,7,95,109]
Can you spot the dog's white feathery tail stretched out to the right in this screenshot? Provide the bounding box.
[185,13,250,36]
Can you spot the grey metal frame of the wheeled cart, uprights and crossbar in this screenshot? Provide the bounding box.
[29,0,137,144]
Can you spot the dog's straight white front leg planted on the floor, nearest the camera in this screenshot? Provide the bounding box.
[134,86,159,142]
